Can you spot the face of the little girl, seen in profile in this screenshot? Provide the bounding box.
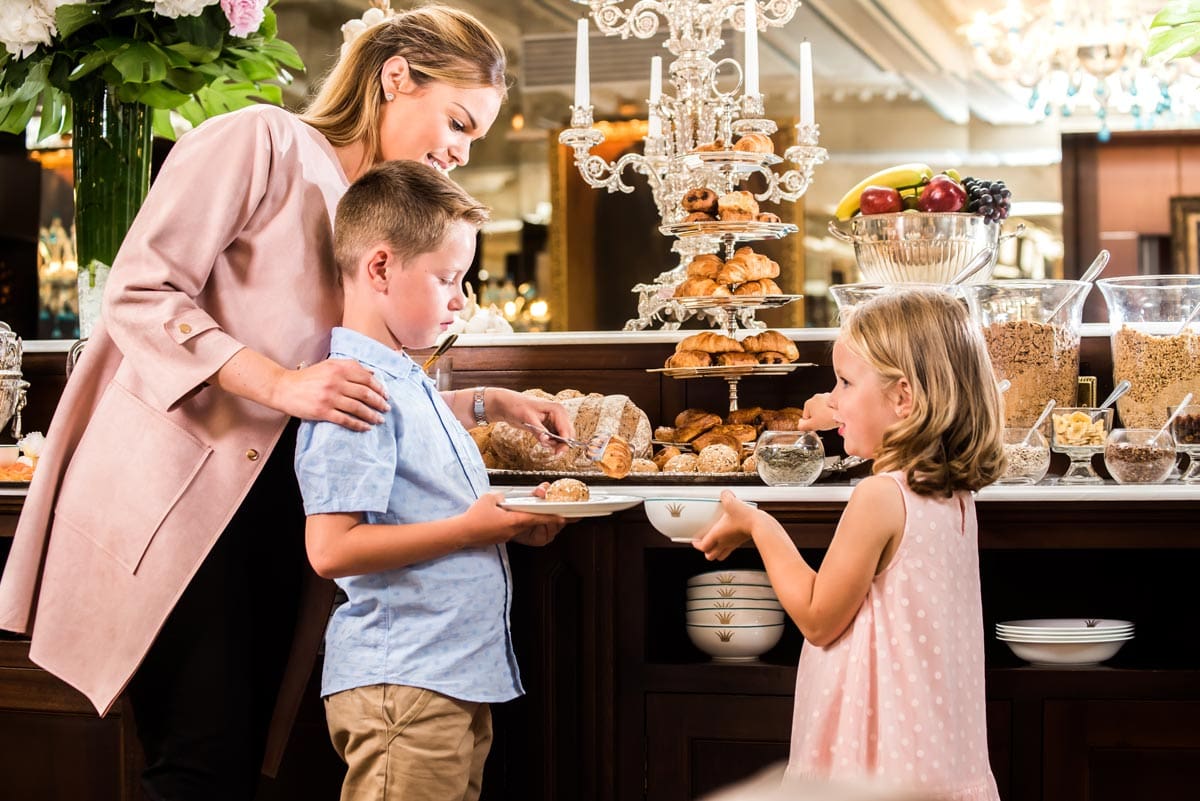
[829,339,908,459]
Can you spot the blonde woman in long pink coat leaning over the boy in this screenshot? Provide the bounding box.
[0,6,571,801]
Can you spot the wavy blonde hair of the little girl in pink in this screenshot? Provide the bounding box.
[841,290,1004,496]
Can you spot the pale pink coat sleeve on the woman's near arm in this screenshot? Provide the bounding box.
[103,107,274,410]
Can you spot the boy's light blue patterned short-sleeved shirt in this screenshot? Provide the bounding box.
[295,329,524,701]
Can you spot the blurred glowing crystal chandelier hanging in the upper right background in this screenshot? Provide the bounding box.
[962,0,1200,140]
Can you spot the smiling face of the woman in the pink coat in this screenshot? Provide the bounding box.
[379,56,502,173]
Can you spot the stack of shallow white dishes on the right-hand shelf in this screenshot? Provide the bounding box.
[996,618,1133,664]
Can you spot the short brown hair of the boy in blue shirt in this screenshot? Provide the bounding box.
[334,161,488,276]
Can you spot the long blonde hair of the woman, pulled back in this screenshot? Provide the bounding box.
[300,5,508,163]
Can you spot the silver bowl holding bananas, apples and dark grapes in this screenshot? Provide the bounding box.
[829,211,1024,284]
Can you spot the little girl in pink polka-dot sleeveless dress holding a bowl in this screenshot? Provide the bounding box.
[696,291,1003,801]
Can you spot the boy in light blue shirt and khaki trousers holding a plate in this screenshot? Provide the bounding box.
[295,162,571,801]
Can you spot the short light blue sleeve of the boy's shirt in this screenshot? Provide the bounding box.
[295,402,397,514]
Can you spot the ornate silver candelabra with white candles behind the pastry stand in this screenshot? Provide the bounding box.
[559,0,827,330]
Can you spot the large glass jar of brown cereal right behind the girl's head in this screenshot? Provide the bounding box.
[961,281,1088,428]
